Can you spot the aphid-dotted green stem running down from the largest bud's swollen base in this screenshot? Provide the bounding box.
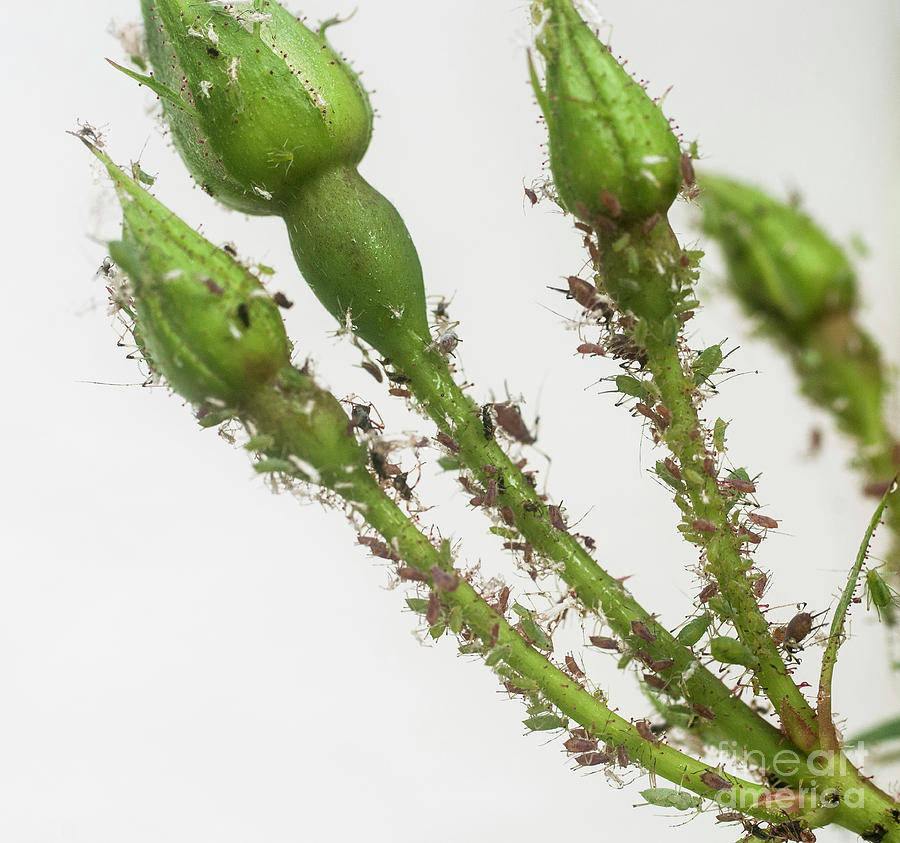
[390,336,800,763]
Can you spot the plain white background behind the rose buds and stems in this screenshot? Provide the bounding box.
[0,0,900,843]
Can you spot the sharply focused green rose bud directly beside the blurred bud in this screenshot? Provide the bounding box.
[531,0,682,224]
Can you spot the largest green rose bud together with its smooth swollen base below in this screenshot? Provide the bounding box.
[128,0,431,368]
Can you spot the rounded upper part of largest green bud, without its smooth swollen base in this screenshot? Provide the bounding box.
[134,0,372,214]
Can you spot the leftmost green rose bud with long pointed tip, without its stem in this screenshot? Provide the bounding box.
[91,147,290,407]
